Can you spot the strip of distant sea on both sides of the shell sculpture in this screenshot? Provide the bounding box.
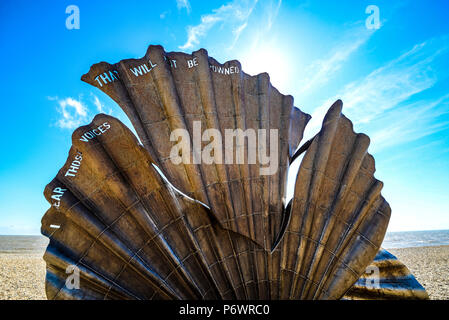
[0,230,449,254]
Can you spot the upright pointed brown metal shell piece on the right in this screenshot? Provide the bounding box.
[272,101,391,299]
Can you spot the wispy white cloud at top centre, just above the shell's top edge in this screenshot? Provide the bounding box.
[179,0,257,50]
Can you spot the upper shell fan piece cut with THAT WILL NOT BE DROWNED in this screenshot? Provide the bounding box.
[82,46,310,250]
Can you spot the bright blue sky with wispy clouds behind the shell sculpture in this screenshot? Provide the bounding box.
[0,0,449,234]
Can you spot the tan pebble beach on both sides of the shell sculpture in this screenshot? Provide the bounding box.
[0,236,449,300]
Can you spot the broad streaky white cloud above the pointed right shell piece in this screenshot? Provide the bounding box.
[307,39,449,152]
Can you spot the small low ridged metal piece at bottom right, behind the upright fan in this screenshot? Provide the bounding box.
[344,249,429,300]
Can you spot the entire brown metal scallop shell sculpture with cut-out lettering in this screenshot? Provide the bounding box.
[42,46,427,299]
